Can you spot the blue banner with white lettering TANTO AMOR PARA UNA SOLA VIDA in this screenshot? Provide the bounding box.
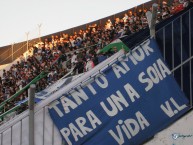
[49,40,188,145]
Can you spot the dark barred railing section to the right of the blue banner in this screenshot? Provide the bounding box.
[156,5,193,108]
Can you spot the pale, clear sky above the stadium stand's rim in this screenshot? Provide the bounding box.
[0,0,150,47]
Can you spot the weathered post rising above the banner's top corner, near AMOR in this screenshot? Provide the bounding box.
[146,3,158,38]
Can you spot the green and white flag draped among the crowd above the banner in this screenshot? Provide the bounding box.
[99,39,129,53]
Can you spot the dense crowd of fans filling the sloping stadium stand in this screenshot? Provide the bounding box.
[0,0,190,121]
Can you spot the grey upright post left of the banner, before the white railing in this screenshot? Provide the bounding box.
[28,84,36,145]
